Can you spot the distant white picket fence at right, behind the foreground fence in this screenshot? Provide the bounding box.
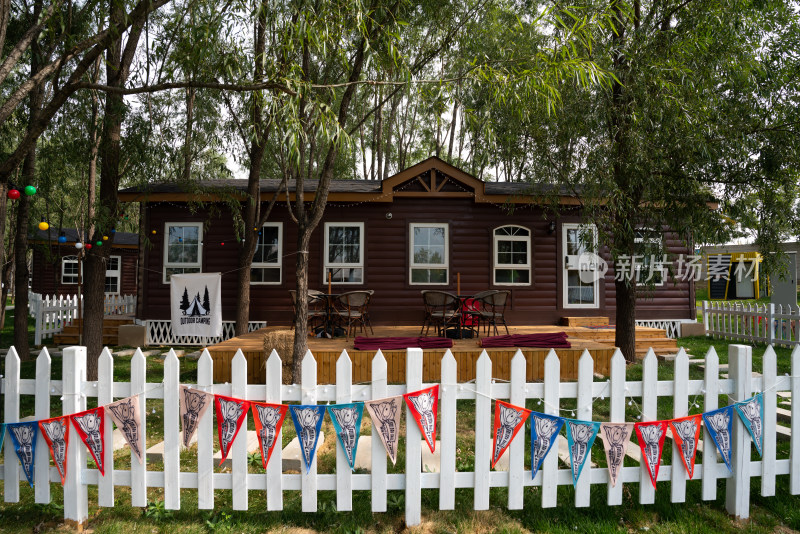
[703,301,800,346]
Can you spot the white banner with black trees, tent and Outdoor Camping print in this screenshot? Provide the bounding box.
[170,273,222,337]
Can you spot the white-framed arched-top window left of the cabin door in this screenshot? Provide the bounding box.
[494,226,531,286]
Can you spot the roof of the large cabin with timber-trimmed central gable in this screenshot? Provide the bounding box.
[119,156,578,204]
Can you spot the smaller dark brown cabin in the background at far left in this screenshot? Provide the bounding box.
[30,227,139,295]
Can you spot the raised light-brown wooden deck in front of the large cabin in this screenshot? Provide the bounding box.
[202,326,674,384]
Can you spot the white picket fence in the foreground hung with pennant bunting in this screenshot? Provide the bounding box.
[0,345,800,525]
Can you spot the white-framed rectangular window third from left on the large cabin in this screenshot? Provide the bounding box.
[322,223,364,284]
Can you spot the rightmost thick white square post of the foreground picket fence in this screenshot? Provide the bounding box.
[725,346,752,519]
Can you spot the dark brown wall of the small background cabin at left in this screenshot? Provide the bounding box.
[31,247,139,295]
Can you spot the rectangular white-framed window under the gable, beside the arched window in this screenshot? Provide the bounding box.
[409,223,448,285]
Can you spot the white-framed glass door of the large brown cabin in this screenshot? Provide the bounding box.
[561,223,601,308]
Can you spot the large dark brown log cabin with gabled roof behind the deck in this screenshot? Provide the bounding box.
[120,157,695,325]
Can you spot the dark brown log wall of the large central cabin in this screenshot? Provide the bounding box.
[140,197,695,325]
